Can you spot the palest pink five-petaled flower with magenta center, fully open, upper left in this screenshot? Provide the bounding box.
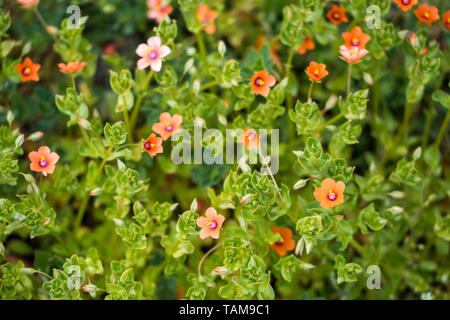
[136,36,170,72]
